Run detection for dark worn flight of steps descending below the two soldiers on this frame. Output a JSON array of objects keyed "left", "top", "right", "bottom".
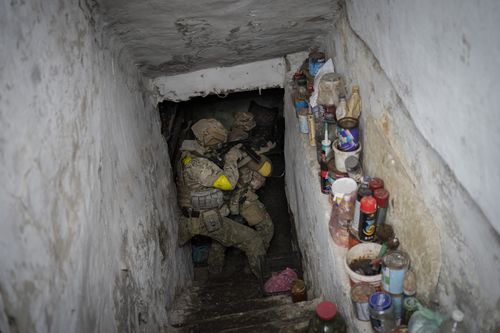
[{"left": 169, "top": 273, "right": 319, "bottom": 333}]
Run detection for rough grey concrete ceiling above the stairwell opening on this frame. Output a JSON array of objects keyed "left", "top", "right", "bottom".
[{"left": 98, "top": 0, "right": 339, "bottom": 77}]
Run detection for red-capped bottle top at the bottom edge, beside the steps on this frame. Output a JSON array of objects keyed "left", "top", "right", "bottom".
[{"left": 307, "top": 301, "right": 347, "bottom": 333}]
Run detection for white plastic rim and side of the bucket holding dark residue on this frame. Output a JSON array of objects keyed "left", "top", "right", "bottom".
[{"left": 344, "top": 243, "right": 382, "bottom": 288}]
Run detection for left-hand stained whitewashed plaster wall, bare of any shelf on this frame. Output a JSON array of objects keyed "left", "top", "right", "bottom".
[{"left": 0, "top": 0, "right": 191, "bottom": 333}]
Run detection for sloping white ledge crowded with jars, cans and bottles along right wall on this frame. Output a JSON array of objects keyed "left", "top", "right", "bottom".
[{"left": 285, "top": 53, "right": 459, "bottom": 332}]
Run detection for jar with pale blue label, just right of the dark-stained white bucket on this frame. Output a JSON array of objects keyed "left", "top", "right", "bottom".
[{"left": 382, "top": 250, "right": 410, "bottom": 295}]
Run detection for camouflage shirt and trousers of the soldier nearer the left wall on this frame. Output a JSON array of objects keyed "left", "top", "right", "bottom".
[{"left": 178, "top": 118, "right": 265, "bottom": 276}]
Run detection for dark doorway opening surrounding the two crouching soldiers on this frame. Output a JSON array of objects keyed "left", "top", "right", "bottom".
[{"left": 159, "top": 89, "right": 301, "bottom": 279}]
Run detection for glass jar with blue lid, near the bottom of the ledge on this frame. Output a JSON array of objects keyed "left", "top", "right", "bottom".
[{"left": 369, "top": 292, "right": 396, "bottom": 333}]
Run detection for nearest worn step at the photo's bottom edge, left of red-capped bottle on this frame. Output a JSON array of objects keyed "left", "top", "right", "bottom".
[{"left": 175, "top": 299, "right": 320, "bottom": 333}]
